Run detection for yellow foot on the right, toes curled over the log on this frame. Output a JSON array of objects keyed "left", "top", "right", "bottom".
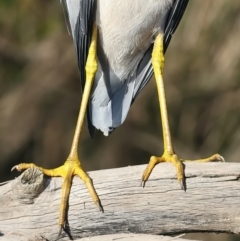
[{"left": 141, "top": 152, "right": 224, "bottom": 190}]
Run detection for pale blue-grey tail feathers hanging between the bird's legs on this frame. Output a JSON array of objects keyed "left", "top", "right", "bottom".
[{"left": 88, "top": 46, "right": 153, "bottom": 136}]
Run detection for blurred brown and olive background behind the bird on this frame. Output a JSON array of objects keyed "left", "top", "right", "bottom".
[{"left": 0, "top": 0, "right": 240, "bottom": 241}]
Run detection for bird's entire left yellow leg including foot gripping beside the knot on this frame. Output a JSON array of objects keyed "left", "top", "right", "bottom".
[{"left": 12, "top": 24, "right": 103, "bottom": 235}]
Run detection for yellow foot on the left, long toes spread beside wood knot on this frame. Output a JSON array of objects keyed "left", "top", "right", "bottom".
[{"left": 11, "top": 158, "right": 103, "bottom": 234}]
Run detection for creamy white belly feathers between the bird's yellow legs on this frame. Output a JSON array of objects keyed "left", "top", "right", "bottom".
[{"left": 96, "top": 0, "right": 173, "bottom": 80}]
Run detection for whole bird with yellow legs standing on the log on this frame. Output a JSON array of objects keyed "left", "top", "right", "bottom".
[{"left": 12, "top": 0, "right": 223, "bottom": 232}]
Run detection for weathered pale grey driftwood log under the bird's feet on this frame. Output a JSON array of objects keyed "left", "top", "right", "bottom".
[{"left": 0, "top": 163, "right": 240, "bottom": 241}]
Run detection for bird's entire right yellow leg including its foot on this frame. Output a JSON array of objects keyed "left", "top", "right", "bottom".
[{"left": 141, "top": 34, "right": 224, "bottom": 190}]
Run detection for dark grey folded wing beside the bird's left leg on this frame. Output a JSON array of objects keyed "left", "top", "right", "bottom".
[{"left": 60, "top": 0, "right": 95, "bottom": 136}]
